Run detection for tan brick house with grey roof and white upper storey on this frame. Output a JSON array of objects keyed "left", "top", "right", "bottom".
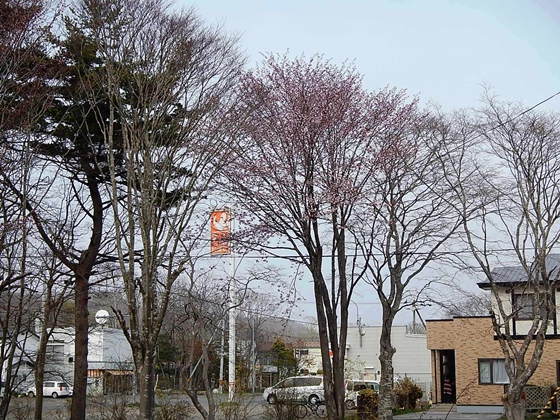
[{"left": 426, "top": 254, "right": 560, "bottom": 414}]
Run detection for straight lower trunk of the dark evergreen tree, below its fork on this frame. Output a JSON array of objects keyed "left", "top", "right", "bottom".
[{"left": 70, "top": 275, "right": 89, "bottom": 420}]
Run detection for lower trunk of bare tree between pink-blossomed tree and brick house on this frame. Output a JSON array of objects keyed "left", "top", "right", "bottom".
[{"left": 378, "top": 320, "right": 395, "bottom": 420}]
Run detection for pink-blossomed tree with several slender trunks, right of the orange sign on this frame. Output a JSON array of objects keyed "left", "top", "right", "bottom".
[{"left": 225, "top": 55, "right": 414, "bottom": 419}]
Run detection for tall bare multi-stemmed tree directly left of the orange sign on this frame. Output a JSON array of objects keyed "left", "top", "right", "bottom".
[{"left": 80, "top": 0, "right": 243, "bottom": 419}]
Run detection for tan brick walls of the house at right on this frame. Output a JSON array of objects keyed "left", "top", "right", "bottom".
[{"left": 427, "top": 317, "right": 560, "bottom": 405}]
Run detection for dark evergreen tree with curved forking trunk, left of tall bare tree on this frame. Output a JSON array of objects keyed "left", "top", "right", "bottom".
[{"left": 0, "top": 1, "right": 122, "bottom": 419}]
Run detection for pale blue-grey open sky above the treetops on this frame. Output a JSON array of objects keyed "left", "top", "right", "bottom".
[{"left": 177, "top": 0, "right": 560, "bottom": 325}]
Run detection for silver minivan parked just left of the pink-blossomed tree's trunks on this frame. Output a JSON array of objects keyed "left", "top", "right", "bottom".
[{"left": 263, "top": 376, "right": 324, "bottom": 404}]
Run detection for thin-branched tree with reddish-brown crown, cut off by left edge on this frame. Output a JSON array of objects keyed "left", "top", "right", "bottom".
[{"left": 0, "top": 0, "right": 67, "bottom": 418}]
